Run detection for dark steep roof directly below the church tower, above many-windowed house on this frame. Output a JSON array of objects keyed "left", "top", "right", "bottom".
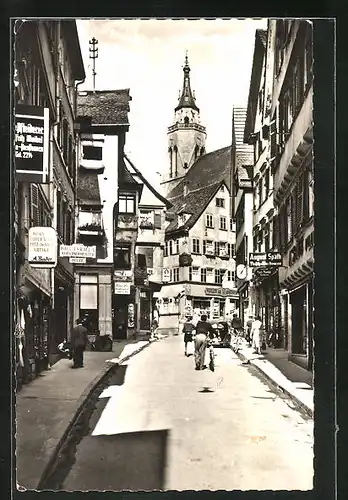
[{"left": 166, "top": 146, "right": 231, "bottom": 232}]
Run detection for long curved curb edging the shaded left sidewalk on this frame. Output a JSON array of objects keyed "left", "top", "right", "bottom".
[{"left": 37, "top": 341, "right": 152, "bottom": 491}]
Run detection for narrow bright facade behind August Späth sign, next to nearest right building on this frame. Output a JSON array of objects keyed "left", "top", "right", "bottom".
[{"left": 244, "top": 26, "right": 287, "bottom": 340}]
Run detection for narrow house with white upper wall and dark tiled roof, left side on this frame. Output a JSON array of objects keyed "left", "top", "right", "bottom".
[{"left": 74, "top": 89, "right": 131, "bottom": 337}]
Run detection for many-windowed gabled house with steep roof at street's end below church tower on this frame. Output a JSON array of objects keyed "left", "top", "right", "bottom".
[{"left": 159, "top": 147, "right": 238, "bottom": 333}]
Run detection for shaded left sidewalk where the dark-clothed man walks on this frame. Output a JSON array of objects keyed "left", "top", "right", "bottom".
[{"left": 16, "top": 340, "right": 149, "bottom": 490}]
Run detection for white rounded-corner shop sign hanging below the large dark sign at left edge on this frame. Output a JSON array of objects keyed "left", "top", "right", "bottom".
[{"left": 28, "top": 227, "right": 57, "bottom": 268}]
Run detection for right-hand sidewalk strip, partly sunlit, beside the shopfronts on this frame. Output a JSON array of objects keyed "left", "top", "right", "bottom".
[{"left": 234, "top": 343, "right": 314, "bottom": 417}]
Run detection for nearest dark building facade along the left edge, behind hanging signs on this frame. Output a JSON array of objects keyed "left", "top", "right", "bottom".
[{"left": 13, "top": 20, "right": 85, "bottom": 386}]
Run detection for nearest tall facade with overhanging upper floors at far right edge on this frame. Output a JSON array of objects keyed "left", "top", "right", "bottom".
[{"left": 268, "top": 20, "right": 314, "bottom": 369}]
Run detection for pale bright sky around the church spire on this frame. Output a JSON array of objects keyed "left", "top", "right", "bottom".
[{"left": 77, "top": 19, "right": 267, "bottom": 188}]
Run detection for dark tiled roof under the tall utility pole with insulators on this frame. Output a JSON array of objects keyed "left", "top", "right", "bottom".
[{"left": 77, "top": 89, "right": 132, "bottom": 125}]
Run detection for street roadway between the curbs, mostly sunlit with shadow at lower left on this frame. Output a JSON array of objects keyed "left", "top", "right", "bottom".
[{"left": 62, "top": 336, "right": 313, "bottom": 491}]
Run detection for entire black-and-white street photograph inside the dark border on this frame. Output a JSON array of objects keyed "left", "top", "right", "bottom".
[{"left": 12, "top": 18, "right": 315, "bottom": 492}]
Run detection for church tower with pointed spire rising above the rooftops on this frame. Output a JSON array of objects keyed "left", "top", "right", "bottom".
[{"left": 161, "top": 52, "right": 207, "bottom": 195}]
